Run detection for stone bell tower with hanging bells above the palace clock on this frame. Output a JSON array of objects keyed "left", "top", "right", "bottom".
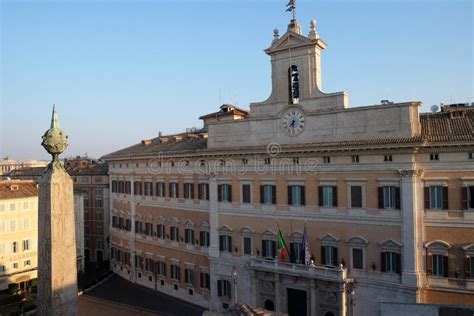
[{"left": 251, "top": 17, "right": 348, "bottom": 116}]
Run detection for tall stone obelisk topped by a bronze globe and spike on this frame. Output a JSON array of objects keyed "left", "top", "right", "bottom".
[{"left": 37, "top": 106, "right": 78, "bottom": 316}]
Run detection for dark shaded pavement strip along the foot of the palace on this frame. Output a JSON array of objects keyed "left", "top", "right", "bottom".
[{"left": 83, "top": 275, "right": 206, "bottom": 316}]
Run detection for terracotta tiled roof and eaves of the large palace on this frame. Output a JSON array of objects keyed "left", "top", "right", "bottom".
[{"left": 102, "top": 108, "right": 474, "bottom": 159}]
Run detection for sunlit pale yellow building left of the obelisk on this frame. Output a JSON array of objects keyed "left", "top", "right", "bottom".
[{"left": 0, "top": 181, "right": 38, "bottom": 290}]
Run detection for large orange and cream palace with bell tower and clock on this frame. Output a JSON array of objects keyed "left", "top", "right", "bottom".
[{"left": 103, "top": 15, "right": 474, "bottom": 316}]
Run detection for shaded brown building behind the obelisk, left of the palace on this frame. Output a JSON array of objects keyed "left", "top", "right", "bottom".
[{"left": 8, "top": 156, "right": 110, "bottom": 262}]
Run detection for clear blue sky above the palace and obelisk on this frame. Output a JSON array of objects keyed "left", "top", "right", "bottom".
[{"left": 0, "top": 0, "right": 474, "bottom": 159}]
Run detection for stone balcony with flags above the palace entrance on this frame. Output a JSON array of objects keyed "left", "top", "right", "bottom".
[{"left": 250, "top": 259, "right": 347, "bottom": 282}]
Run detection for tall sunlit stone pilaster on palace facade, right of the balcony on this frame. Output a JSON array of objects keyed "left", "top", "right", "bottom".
[{"left": 400, "top": 170, "right": 423, "bottom": 289}]
